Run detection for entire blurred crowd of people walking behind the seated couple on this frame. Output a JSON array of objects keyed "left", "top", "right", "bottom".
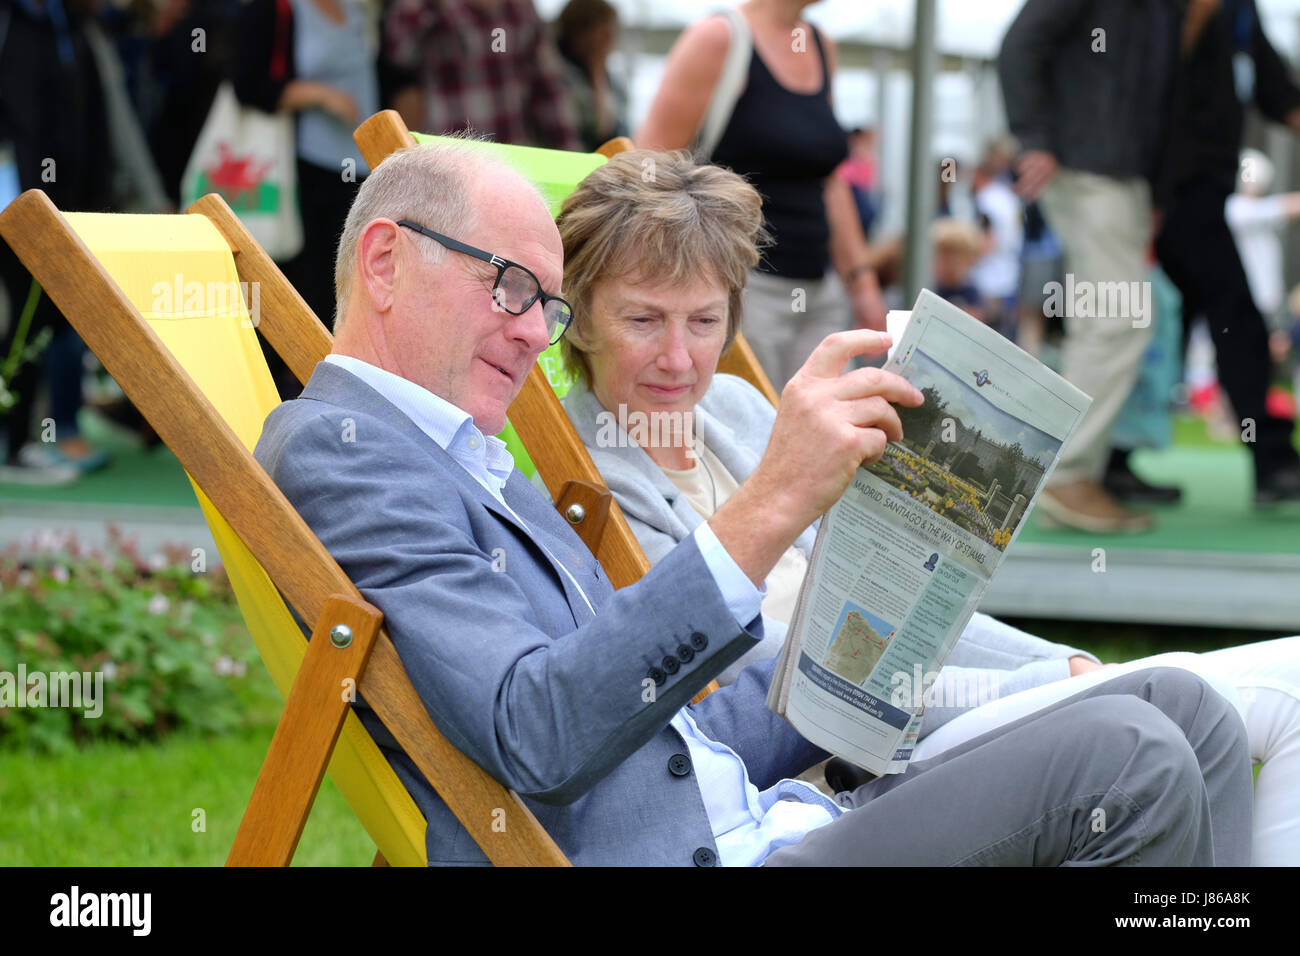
[{"left": 0, "top": 0, "right": 1300, "bottom": 531}]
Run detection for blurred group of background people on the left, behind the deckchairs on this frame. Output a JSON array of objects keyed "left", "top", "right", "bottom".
[{"left": 0, "top": 0, "right": 628, "bottom": 485}]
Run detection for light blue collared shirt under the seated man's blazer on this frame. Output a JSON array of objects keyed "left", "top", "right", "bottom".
[{"left": 325, "top": 355, "right": 844, "bottom": 866}]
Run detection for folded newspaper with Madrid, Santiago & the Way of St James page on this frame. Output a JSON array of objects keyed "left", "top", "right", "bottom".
[{"left": 767, "top": 290, "right": 1092, "bottom": 774}]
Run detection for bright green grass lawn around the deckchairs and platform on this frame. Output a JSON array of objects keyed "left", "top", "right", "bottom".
[{"left": 0, "top": 408, "right": 1283, "bottom": 866}]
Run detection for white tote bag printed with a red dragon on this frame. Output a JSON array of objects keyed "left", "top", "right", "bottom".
[{"left": 181, "top": 81, "right": 303, "bottom": 261}]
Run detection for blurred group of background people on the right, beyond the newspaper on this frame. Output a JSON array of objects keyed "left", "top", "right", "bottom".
[{"left": 840, "top": 0, "right": 1300, "bottom": 532}]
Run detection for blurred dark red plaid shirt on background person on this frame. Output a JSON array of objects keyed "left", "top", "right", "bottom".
[{"left": 384, "top": 0, "right": 582, "bottom": 150}]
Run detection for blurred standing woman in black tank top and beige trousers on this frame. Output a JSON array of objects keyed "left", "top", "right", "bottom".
[{"left": 636, "top": 0, "right": 884, "bottom": 388}]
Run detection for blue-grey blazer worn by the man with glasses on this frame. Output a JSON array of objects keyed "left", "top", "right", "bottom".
[{"left": 255, "top": 363, "right": 827, "bottom": 866}]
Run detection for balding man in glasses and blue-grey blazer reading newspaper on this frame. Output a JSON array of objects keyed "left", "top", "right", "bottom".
[{"left": 256, "top": 141, "right": 1251, "bottom": 866}]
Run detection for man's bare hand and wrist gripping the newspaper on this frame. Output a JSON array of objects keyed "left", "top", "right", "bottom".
[{"left": 709, "top": 329, "right": 924, "bottom": 587}]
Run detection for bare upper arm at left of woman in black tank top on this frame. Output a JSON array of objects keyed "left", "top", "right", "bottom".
[{"left": 633, "top": 17, "right": 731, "bottom": 150}]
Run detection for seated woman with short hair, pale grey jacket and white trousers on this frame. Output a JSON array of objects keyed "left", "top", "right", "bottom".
[{"left": 558, "top": 151, "right": 1300, "bottom": 865}]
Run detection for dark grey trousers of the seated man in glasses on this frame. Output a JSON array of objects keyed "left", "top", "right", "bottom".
[{"left": 767, "top": 667, "right": 1252, "bottom": 866}]
